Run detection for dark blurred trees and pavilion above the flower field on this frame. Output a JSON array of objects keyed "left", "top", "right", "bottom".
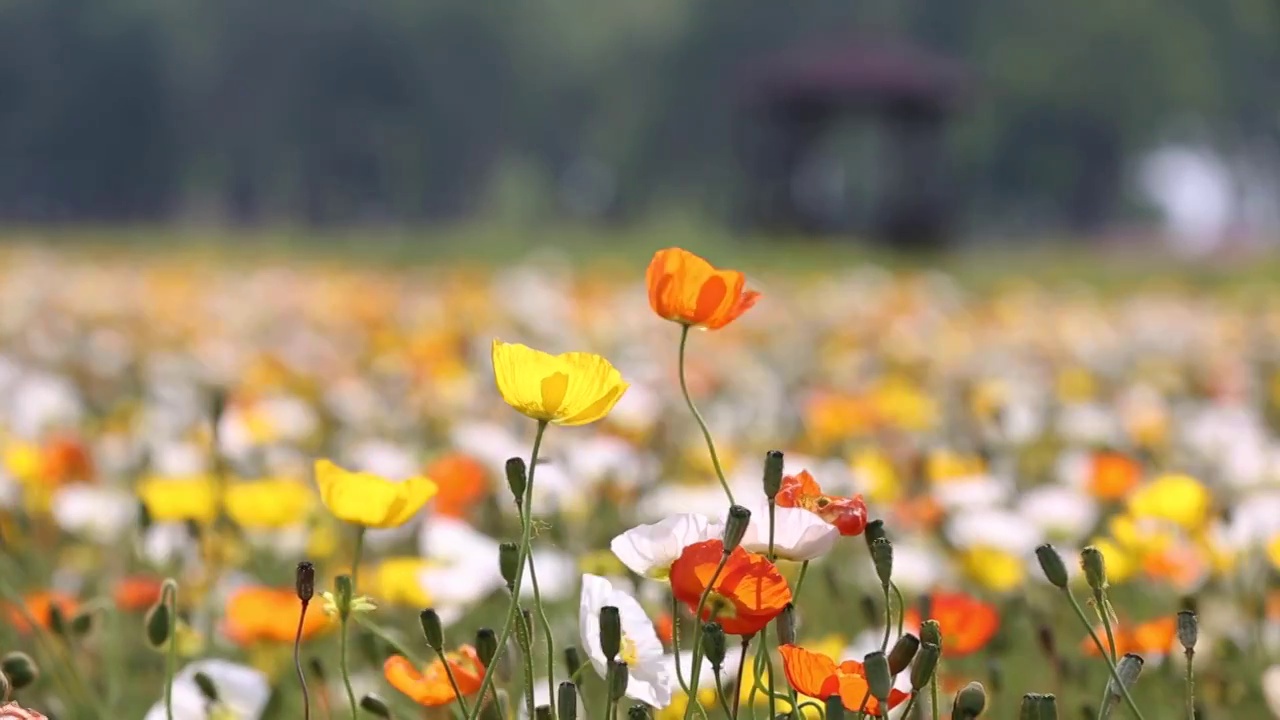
[{"left": 0, "top": 0, "right": 1280, "bottom": 254}]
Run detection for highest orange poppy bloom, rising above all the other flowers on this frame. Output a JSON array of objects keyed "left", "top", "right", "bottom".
[{"left": 645, "top": 247, "right": 760, "bottom": 331}]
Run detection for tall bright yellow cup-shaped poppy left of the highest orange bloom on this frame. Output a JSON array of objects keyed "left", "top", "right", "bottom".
[{"left": 493, "top": 340, "right": 630, "bottom": 425}]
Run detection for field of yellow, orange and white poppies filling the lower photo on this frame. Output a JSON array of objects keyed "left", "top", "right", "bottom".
[{"left": 0, "top": 242, "right": 1280, "bottom": 720}]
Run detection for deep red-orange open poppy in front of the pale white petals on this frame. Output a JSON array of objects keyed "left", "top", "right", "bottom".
[{"left": 671, "top": 539, "right": 791, "bottom": 635}]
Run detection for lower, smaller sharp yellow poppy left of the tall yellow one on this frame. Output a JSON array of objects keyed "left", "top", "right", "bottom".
[{"left": 316, "top": 460, "right": 438, "bottom": 528}]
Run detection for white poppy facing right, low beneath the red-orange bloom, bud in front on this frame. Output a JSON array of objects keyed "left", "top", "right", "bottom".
[{"left": 579, "top": 575, "right": 675, "bottom": 707}]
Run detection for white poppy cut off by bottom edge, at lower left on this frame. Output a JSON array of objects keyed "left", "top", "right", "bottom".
[{"left": 143, "top": 660, "right": 271, "bottom": 720}]
